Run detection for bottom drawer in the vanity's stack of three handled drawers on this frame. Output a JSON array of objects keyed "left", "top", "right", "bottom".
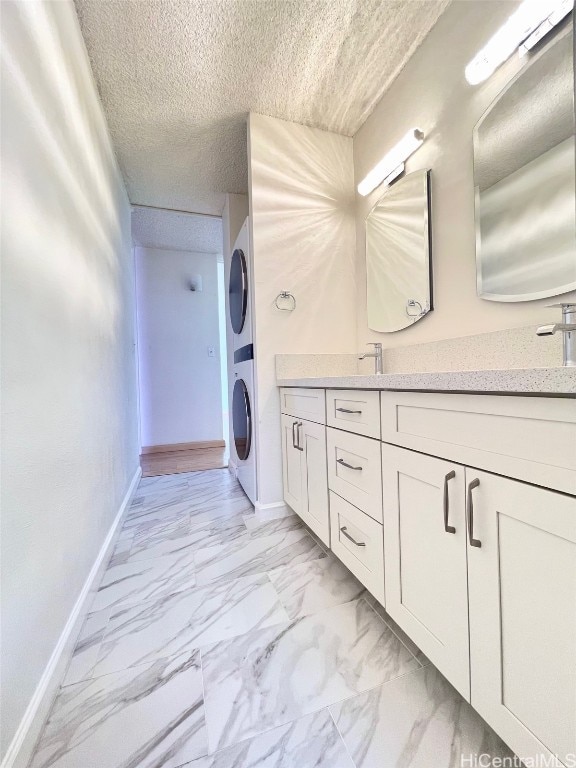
[{"left": 330, "top": 491, "right": 384, "bottom": 605}]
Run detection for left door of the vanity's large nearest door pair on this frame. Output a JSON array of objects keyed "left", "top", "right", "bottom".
[{"left": 382, "top": 444, "right": 470, "bottom": 700}]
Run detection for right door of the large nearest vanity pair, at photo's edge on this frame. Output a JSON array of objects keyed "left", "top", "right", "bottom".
[{"left": 466, "top": 468, "right": 576, "bottom": 765}]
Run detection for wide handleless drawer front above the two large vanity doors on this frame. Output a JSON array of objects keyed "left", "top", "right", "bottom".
[{"left": 381, "top": 392, "right": 576, "bottom": 495}]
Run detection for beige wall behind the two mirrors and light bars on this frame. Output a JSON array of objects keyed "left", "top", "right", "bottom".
[{"left": 354, "top": 0, "right": 576, "bottom": 347}]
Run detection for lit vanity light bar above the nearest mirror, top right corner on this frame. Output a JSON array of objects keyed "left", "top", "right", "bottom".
[{"left": 465, "top": 0, "right": 574, "bottom": 85}]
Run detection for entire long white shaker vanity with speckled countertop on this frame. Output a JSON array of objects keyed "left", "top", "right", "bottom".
[{"left": 278, "top": 378, "right": 576, "bottom": 765}]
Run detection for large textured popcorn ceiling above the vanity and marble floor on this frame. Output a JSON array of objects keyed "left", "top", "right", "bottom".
[{"left": 76, "top": 0, "right": 448, "bottom": 214}]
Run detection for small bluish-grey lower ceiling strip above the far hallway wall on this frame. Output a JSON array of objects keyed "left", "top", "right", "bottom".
[{"left": 132, "top": 208, "right": 222, "bottom": 254}]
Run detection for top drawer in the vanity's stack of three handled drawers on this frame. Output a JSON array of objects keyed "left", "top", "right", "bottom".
[{"left": 326, "top": 389, "right": 380, "bottom": 439}]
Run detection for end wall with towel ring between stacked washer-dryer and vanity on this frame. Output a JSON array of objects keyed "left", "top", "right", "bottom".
[{"left": 248, "top": 114, "right": 356, "bottom": 505}]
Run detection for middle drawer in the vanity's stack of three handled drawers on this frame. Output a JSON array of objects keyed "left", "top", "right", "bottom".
[{"left": 327, "top": 427, "right": 382, "bottom": 522}]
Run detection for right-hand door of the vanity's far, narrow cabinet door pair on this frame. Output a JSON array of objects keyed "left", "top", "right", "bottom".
[{"left": 297, "top": 421, "right": 330, "bottom": 547}]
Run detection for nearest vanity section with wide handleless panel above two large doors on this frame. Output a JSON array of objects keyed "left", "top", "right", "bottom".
[{"left": 382, "top": 392, "right": 576, "bottom": 765}]
